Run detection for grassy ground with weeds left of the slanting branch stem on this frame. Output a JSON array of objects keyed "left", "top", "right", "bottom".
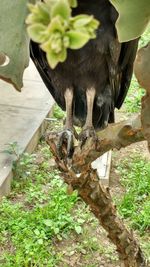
[{"left": 0, "top": 144, "right": 117, "bottom": 267}]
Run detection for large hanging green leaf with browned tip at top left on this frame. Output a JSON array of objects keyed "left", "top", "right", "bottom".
[{"left": 0, "top": 0, "right": 33, "bottom": 91}]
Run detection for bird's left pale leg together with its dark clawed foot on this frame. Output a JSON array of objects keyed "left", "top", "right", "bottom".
[{"left": 57, "top": 88, "right": 74, "bottom": 158}]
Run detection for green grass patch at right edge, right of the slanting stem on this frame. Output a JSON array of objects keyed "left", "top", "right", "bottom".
[{"left": 118, "top": 155, "right": 150, "bottom": 233}]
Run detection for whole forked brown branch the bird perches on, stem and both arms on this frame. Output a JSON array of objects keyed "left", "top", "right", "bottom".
[{"left": 46, "top": 116, "right": 147, "bottom": 267}]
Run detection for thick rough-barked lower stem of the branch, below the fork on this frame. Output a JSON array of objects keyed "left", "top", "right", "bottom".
[{"left": 64, "top": 169, "right": 146, "bottom": 267}]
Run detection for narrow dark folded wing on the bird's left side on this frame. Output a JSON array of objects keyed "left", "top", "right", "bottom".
[{"left": 30, "top": 41, "right": 65, "bottom": 110}]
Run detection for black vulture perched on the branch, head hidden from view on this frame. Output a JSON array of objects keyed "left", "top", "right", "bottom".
[{"left": 30, "top": 0, "right": 138, "bottom": 157}]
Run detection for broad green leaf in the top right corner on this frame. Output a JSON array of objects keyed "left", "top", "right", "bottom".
[{"left": 109, "top": 0, "right": 150, "bottom": 42}]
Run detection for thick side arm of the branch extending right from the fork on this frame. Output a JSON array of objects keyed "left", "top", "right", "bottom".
[{"left": 73, "top": 116, "right": 145, "bottom": 169}]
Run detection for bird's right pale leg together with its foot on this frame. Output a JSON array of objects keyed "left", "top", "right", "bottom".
[{"left": 79, "top": 87, "right": 96, "bottom": 144}]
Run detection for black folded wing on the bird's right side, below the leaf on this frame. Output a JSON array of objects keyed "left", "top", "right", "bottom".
[{"left": 108, "top": 39, "right": 139, "bottom": 109}]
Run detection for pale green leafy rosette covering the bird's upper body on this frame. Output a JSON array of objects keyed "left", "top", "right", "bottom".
[{"left": 26, "top": 0, "right": 99, "bottom": 69}]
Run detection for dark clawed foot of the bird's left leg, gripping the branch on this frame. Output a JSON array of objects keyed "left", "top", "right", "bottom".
[{"left": 57, "top": 129, "right": 74, "bottom": 159}]
